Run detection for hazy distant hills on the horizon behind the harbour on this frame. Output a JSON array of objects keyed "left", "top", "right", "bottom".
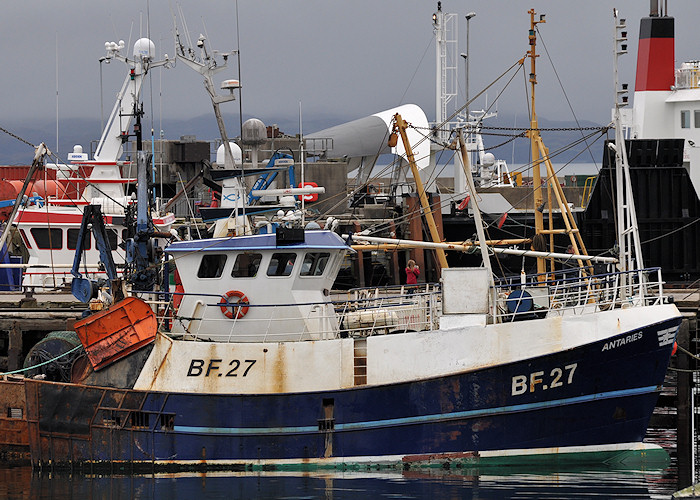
[{"left": 0, "top": 113, "right": 602, "bottom": 169}]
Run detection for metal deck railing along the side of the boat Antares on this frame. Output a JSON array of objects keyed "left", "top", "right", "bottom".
[{"left": 152, "top": 268, "right": 665, "bottom": 342}]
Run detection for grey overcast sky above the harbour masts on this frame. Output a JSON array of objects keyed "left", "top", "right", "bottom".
[{"left": 0, "top": 0, "right": 700, "bottom": 145}]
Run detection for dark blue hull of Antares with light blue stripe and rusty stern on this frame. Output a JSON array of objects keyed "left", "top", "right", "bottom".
[{"left": 26, "top": 318, "right": 680, "bottom": 468}]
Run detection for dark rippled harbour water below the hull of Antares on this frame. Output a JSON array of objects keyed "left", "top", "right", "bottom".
[{"left": 0, "top": 429, "right": 679, "bottom": 500}]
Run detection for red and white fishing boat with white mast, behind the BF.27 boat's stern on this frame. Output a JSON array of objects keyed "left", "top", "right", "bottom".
[{"left": 12, "top": 38, "right": 175, "bottom": 289}]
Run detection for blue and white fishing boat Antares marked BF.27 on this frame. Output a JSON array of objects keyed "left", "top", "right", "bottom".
[{"left": 20, "top": 6, "right": 681, "bottom": 472}]
